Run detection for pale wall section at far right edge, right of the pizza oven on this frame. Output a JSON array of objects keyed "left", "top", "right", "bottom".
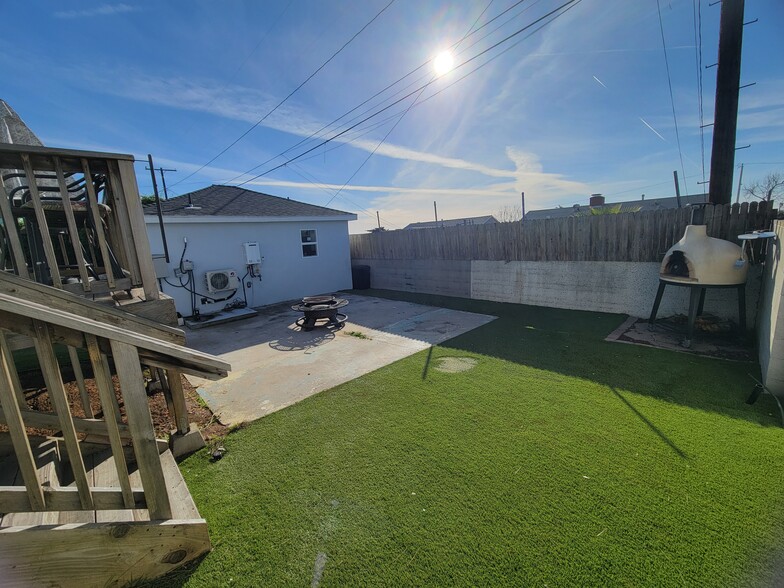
[{"left": 758, "top": 221, "right": 784, "bottom": 396}]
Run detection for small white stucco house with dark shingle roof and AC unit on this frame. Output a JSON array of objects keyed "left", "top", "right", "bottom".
[{"left": 144, "top": 185, "right": 357, "bottom": 317}]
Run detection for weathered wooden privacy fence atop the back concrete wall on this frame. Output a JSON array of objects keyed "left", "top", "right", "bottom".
[{"left": 350, "top": 202, "right": 775, "bottom": 261}]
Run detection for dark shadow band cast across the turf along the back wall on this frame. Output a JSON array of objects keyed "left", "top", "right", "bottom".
[{"left": 356, "top": 290, "right": 781, "bottom": 428}]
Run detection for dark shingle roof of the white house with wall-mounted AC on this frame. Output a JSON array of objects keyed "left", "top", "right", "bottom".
[{"left": 144, "top": 185, "right": 354, "bottom": 217}]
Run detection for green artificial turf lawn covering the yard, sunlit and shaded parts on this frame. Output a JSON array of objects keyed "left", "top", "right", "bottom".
[{"left": 153, "top": 292, "right": 784, "bottom": 587}]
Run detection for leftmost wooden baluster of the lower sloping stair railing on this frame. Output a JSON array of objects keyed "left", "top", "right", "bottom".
[{"left": 0, "top": 335, "right": 46, "bottom": 511}]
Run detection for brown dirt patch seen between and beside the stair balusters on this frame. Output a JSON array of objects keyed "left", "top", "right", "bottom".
[{"left": 0, "top": 376, "right": 228, "bottom": 440}]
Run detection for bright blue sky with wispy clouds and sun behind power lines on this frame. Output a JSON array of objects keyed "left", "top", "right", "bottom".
[{"left": 0, "top": 0, "right": 784, "bottom": 232}]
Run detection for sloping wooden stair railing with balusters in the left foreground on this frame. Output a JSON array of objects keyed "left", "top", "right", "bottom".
[{"left": 0, "top": 290, "right": 230, "bottom": 520}]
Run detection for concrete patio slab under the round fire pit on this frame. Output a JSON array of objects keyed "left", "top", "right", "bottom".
[{"left": 186, "top": 295, "right": 496, "bottom": 425}]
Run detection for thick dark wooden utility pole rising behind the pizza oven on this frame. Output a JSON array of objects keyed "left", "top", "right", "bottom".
[{"left": 709, "top": 0, "right": 744, "bottom": 204}]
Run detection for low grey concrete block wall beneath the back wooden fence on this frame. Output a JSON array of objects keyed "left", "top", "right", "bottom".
[{"left": 352, "top": 259, "right": 760, "bottom": 327}]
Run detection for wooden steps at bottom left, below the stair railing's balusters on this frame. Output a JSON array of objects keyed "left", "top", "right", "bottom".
[{"left": 0, "top": 434, "right": 211, "bottom": 588}]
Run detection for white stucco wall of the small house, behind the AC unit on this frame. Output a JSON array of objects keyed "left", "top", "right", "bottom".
[{"left": 145, "top": 218, "right": 351, "bottom": 316}]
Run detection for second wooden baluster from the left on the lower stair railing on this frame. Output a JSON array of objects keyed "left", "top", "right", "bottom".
[{"left": 33, "top": 320, "right": 94, "bottom": 510}]
